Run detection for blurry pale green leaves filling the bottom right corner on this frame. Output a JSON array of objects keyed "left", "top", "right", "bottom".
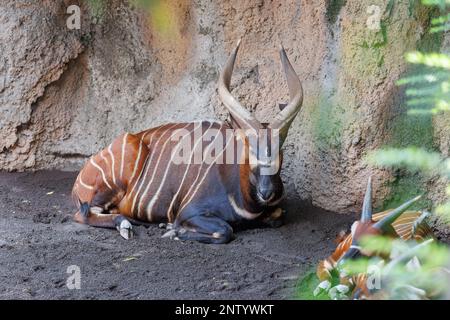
[{"left": 342, "top": 236, "right": 450, "bottom": 299}]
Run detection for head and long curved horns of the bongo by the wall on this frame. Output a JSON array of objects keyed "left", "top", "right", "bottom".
[{"left": 218, "top": 40, "right": 303, "bottom": 206}]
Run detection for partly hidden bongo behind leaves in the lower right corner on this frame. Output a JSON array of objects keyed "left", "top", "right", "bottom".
[{"left": 316, "top": 178, "right": 432, "bottom": 298}]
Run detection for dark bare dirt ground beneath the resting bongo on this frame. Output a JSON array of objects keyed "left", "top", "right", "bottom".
[{"left": 0, "top": 171, "right": 353, "bottom": 299}]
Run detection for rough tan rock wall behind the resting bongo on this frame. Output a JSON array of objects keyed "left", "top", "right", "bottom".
[{"left": 0, "top": 0, "right": 450, "bottom": 212}]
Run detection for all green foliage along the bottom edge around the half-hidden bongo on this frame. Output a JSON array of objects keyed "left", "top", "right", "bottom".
[{"left": 308, "top": 236, "right": 450, "bottom": 300}]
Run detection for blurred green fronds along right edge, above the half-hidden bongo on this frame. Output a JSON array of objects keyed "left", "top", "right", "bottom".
[{"left": 368, "top": 0, "right": 450, "bottom": 220}]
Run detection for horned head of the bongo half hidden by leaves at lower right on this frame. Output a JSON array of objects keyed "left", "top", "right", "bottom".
[{"left": 339, "top": 177, "right": 421, "bottom": 263}]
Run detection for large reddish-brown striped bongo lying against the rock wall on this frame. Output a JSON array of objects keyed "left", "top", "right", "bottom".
[{"left": 72, "top": 42, "right": 303, "bottom": 243}]
